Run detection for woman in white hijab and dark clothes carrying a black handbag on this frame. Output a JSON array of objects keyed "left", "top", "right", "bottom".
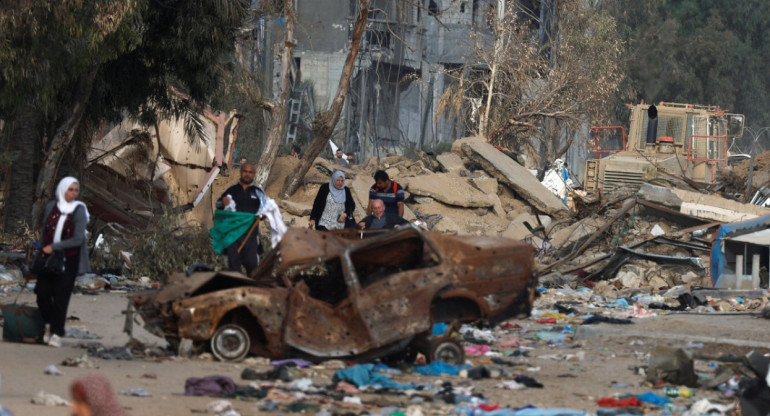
[{"left": 35, "top": 176, "right": 91, "bottom": 347}]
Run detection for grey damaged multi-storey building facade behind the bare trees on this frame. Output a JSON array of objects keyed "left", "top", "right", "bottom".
[{"left": 264, "top": 0, "right": 496, "bottom": 160}]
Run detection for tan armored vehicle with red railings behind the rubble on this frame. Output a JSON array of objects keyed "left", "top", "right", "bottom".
[{"left": 584, "top": 102, "right": 744, "bottom": 191}]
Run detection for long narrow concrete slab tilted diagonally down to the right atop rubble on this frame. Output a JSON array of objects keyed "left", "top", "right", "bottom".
[{"left": 462, "top": 142, "right": 567, "bottom": 215}]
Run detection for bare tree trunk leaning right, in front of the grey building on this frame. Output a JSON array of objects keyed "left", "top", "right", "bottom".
[{"left": 278, "top": 0, "right": 369, "bottom": 199}]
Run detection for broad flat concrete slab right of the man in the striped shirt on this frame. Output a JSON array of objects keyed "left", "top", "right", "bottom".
[{"left": 409, "top": 173, "right": 492, "bottom": 208}]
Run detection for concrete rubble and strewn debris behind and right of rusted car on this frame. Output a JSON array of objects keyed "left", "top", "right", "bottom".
[{"left": 0, "top": 138, "right": 770, "bottom": 415}]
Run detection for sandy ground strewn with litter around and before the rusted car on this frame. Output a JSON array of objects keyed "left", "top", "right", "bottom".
[{"left": 0, "top": 293, "right": 770, "bottom": 416}]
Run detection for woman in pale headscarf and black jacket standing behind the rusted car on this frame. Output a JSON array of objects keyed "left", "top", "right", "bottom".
[{"left": 308, "top": 170, "right": 356, "bottom": 230}]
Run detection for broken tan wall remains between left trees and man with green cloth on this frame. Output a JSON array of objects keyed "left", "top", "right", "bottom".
[{"left": 85, "top": 113, "right": 237, "bottom": 227}]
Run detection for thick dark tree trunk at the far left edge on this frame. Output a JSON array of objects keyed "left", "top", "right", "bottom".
[{"left": 5, "top": 106, "right": 42, "bottom": 234}]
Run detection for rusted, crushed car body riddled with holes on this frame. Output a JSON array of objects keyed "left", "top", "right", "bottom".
[{"left": 132, "top": 225, "right": 536, "bottom": 360}]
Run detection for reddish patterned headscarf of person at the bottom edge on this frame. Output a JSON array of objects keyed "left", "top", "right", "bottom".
[{"left": 70, "top": 374, "right": 126, "bottom": 416}]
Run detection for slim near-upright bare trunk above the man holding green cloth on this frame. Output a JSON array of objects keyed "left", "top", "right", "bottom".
[{"left": 254, "top": 0, "right": 294, "bottom": 188}]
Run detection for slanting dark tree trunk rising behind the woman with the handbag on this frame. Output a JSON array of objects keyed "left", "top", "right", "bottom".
[{"left": 32, "top": 69, "right": 96, "bottom": 230}]
